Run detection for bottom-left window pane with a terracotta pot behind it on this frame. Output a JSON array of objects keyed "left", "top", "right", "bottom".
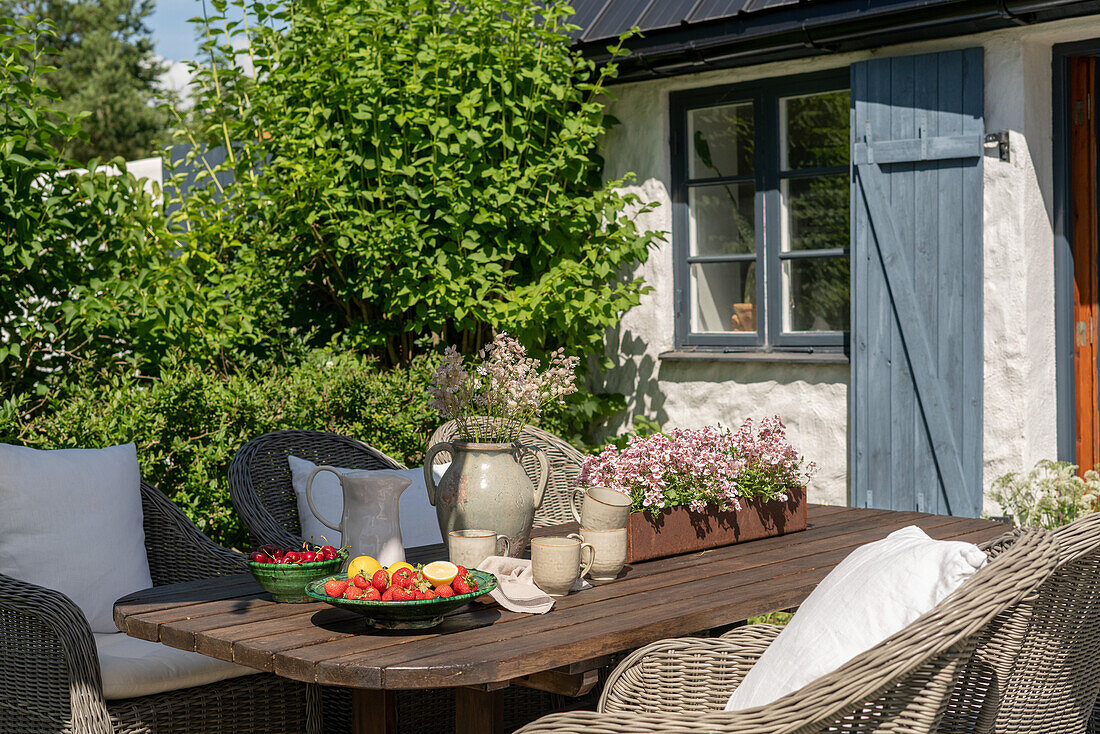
[{"left": 691, "top": 261, "right": 757, "bottom": 332}]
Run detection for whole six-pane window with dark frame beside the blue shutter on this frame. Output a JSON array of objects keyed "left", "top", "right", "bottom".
[{"left": 671, "top": 69, "right": 850, "bottom": 351}]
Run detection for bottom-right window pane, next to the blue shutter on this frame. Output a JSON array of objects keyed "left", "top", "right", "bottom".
[{"left": 783, "top": 258, "right": 849, "bottom": 331}]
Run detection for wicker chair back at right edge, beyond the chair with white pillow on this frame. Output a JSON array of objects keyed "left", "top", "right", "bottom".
[{"left": 942, "top": 514, "right": 1100, "bottom": 734}]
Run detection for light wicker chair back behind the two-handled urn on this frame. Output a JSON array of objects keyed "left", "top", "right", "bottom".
[{"left": 428, "top": 420, "right": 584, "bottom": 527}]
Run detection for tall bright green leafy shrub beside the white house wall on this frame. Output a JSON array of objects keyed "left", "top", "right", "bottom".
[{"left": 170, "top": 0, "right": 655, "bottom": 363}]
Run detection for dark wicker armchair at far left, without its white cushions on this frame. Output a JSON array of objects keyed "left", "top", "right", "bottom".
[{"left": 0, "top": 482, "right": 320, "bottom": 734}]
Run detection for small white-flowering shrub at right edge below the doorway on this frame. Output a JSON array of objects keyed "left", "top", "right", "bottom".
[{"left": 989, "top": 459, "right": 1100, "bottom": 529}]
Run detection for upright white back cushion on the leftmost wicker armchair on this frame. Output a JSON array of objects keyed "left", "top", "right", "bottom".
[{"left": 0, "top": 443, "right": 153, "bottom": 632}]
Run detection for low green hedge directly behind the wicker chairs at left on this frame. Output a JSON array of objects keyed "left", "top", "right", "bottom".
[{"left": 0, "top": 350, "right": 439, "bottom": 548}]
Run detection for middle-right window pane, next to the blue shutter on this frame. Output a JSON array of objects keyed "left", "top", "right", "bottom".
[{"left": 780, "top": 173, "right": 850, "bottom": 251}]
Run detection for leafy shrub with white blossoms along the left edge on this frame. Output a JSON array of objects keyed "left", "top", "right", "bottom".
[{"left": 0, "top": 18, "right": 249, "bottom": 415}]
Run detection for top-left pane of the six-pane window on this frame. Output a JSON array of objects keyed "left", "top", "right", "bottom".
[{"left": 688, "top": 102, "right": 752, "bottom": 178}]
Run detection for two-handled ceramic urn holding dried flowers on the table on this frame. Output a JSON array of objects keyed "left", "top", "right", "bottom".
[{"left": 424, "top": 441, "right": 550, "bottom": 558}]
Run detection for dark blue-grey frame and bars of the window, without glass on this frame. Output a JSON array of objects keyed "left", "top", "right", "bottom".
[{"left": 669, "top": 67, "right": 851, "bottom": 352}]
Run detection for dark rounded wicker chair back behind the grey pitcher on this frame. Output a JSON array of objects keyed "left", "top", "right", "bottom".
[{"left": 229, "top": 430, "right": 405, "bottom": 547}]
